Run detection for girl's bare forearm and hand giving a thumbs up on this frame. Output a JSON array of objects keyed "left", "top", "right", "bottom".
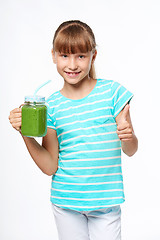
[{"left": 116, "top": 104, "right": 138, "bottom": 156}]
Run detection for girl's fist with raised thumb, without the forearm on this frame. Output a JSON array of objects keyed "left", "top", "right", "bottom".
[{"left": 116, "top": 104, "right": 133, "bottom": 142}]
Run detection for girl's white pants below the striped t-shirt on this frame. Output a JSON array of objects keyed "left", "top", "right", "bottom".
[{"left": 52, "top": 204, "right": 121, "bottom": 240}]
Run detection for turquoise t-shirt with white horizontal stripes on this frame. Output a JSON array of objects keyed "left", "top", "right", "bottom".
[{"left": 46, "top": 79, "right": 133, "bottom": 211}]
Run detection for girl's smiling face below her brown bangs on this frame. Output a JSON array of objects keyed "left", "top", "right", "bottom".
[{"left": 52, "top": 49, "right": 96, "bottom": 84}]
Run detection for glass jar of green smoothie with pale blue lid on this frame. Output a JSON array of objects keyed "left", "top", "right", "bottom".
[{"left": 21, "top": 96, "right": 47, "bottom": 137}]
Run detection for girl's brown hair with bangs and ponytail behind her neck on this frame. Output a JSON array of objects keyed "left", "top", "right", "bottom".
[{"left": 53, "top": 20, "right": 96, "bottom": 78}]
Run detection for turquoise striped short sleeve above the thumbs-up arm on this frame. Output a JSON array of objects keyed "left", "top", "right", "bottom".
[{"left": 111, "top": 81, "right": 133, "bottom": 117}]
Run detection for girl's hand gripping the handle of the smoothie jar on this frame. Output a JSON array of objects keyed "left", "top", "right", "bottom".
[{"left": 8, "top": 108, "right": 22, "bottom": 131}]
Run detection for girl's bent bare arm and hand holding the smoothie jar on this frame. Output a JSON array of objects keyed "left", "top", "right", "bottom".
[{"left": 9, "top": 108, "right": 59, "bottom": 175}]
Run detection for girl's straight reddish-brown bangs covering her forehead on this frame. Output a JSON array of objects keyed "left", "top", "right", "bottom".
[{"left": 53, "top": 25, "right": 95, "bottom": 54}]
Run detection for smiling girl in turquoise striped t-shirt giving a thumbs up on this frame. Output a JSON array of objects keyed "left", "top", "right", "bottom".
[{"left": 9, "top": 21, "right": 138, "bottom": 240}]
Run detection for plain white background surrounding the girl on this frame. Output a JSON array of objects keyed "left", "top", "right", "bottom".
[{"left": 0, "top": 0, "right": 160, "bottom": 240}]
